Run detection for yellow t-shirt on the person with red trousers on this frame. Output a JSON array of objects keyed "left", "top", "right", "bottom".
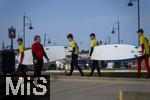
[{"left": 140, "top": 35, "right": 150, "bottom": 55}]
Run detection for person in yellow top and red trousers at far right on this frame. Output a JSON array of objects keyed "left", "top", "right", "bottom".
[{"left": 137, "top": 29, "right": 150, "bottom": 78}]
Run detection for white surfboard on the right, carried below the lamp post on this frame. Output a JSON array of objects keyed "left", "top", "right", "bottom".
[{"left": 91, "top": 44, "right": 141, "bottom": 60}]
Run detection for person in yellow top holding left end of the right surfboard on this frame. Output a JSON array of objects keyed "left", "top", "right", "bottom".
[{"left": 88, "top": 33, "right": 101, "bottom": 77}]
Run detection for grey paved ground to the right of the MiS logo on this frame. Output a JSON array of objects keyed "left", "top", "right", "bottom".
[{"left": 50, "top": 76, "right": 150, "bottom": 100}]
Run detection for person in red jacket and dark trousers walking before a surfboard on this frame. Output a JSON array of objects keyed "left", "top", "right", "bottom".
[{"left": 32, "top": 35, "right": 49, "bottom": 85}]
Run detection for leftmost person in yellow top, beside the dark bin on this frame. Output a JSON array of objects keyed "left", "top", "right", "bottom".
[{"left": 17, "top": 38, "right": 27, "bottom": 82}]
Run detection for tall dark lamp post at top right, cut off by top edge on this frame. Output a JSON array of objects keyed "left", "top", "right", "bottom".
[{"left": 128, "top": 0, "right": 140, "bottom": 45}]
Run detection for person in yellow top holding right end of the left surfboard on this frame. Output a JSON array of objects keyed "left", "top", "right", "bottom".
[{"left": 67, "top": 34, "right": 84, "bottom": 76}]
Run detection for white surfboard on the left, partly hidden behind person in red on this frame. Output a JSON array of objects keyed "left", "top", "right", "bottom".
[{"left": 18, "top": 46, "right": 71, "bottom": 65}]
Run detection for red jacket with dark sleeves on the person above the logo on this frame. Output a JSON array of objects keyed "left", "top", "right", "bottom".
[{"left": 32, "top": 43, "right": 48, "bottom": 59}]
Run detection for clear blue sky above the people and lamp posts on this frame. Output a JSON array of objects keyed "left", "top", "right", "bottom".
[{"left": 0, "top": 0, "right": 150, "bottom": 50}]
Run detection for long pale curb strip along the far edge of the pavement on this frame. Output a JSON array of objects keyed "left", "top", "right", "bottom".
[{"left": 50, "top": 75, "right": 150, "bottom": 85}]
